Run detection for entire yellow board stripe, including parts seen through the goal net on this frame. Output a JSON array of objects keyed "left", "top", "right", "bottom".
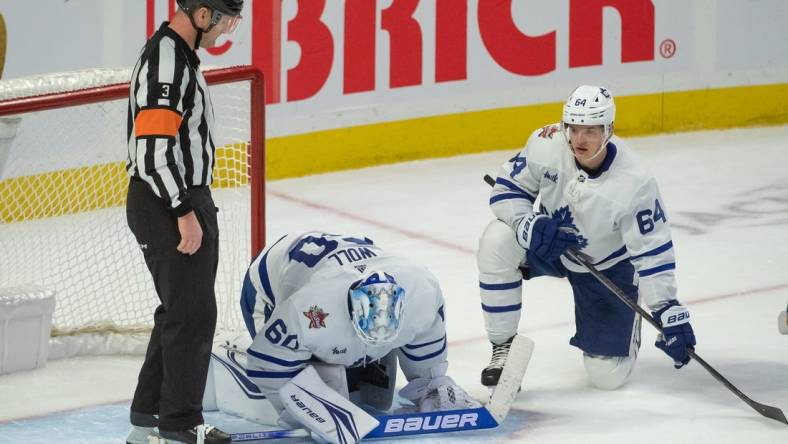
[{"left": 0, "top": 84, "right": 788, "bottom": 223}]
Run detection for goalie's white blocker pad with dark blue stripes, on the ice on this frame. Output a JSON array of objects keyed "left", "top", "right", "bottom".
[{"left": 279, "top": 365, "right": 378, "bottom": 444}]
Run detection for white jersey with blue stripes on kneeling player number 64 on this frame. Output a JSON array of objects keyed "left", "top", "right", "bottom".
[{"left": 490, "top": 124, "right": 676, "bottom": 310}]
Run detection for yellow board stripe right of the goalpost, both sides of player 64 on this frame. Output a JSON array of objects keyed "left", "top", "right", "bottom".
[{"left": 266, "top": 84, "right": 788, "bottom": 179}]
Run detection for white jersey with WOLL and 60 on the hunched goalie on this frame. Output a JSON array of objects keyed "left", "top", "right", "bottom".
[{"left": 241, "top": 232, "right": 446, "bottom": 404}]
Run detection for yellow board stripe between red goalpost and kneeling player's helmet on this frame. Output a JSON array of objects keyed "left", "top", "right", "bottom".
[{"left": 266, "top": 104, "right": 561, "bottom": 179}]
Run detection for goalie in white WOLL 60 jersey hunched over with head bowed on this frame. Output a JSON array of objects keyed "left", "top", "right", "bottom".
[{"left": 235, "top": 232, "right": 480, "bottom": 440}]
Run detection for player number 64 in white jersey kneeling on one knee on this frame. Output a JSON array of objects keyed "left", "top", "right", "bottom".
[{"left": 478, "top": 86, "right": 695, "bottom": 389}]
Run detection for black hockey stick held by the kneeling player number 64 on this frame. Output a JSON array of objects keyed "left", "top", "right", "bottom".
[{"left": 484, "top": 174, "right": 788, "bottom": 425}]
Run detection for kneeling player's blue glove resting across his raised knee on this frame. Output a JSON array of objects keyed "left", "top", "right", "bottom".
[{"left": 516, "top": 214, "right": 580, "bottom": 262}]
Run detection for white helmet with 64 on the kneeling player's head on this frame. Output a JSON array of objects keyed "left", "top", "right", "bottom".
[{"left": 561, "top": 85, "right": 616, "bottom": 142}]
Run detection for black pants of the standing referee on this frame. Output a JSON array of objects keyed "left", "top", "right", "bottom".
[{"left": 126, "top": 179, "right": 219, "bottom": 431}]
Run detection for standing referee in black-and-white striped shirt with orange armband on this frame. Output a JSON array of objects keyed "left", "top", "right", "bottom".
[{"left": 126, "top": 0, "right": 243, "bottom": 444}]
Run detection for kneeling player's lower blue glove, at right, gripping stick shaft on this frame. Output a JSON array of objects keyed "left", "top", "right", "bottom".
[{"left": 652, "top": 301, "right": 695, "bottom": 368}]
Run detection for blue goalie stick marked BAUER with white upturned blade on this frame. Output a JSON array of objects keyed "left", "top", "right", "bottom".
[{"left": 231, "top": 335, "right": 534, "bottom": 442}]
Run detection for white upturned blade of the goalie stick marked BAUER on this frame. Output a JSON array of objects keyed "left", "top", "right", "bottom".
[{"left": 487, "top": 335, "right": 534, "bottom": 424}]
